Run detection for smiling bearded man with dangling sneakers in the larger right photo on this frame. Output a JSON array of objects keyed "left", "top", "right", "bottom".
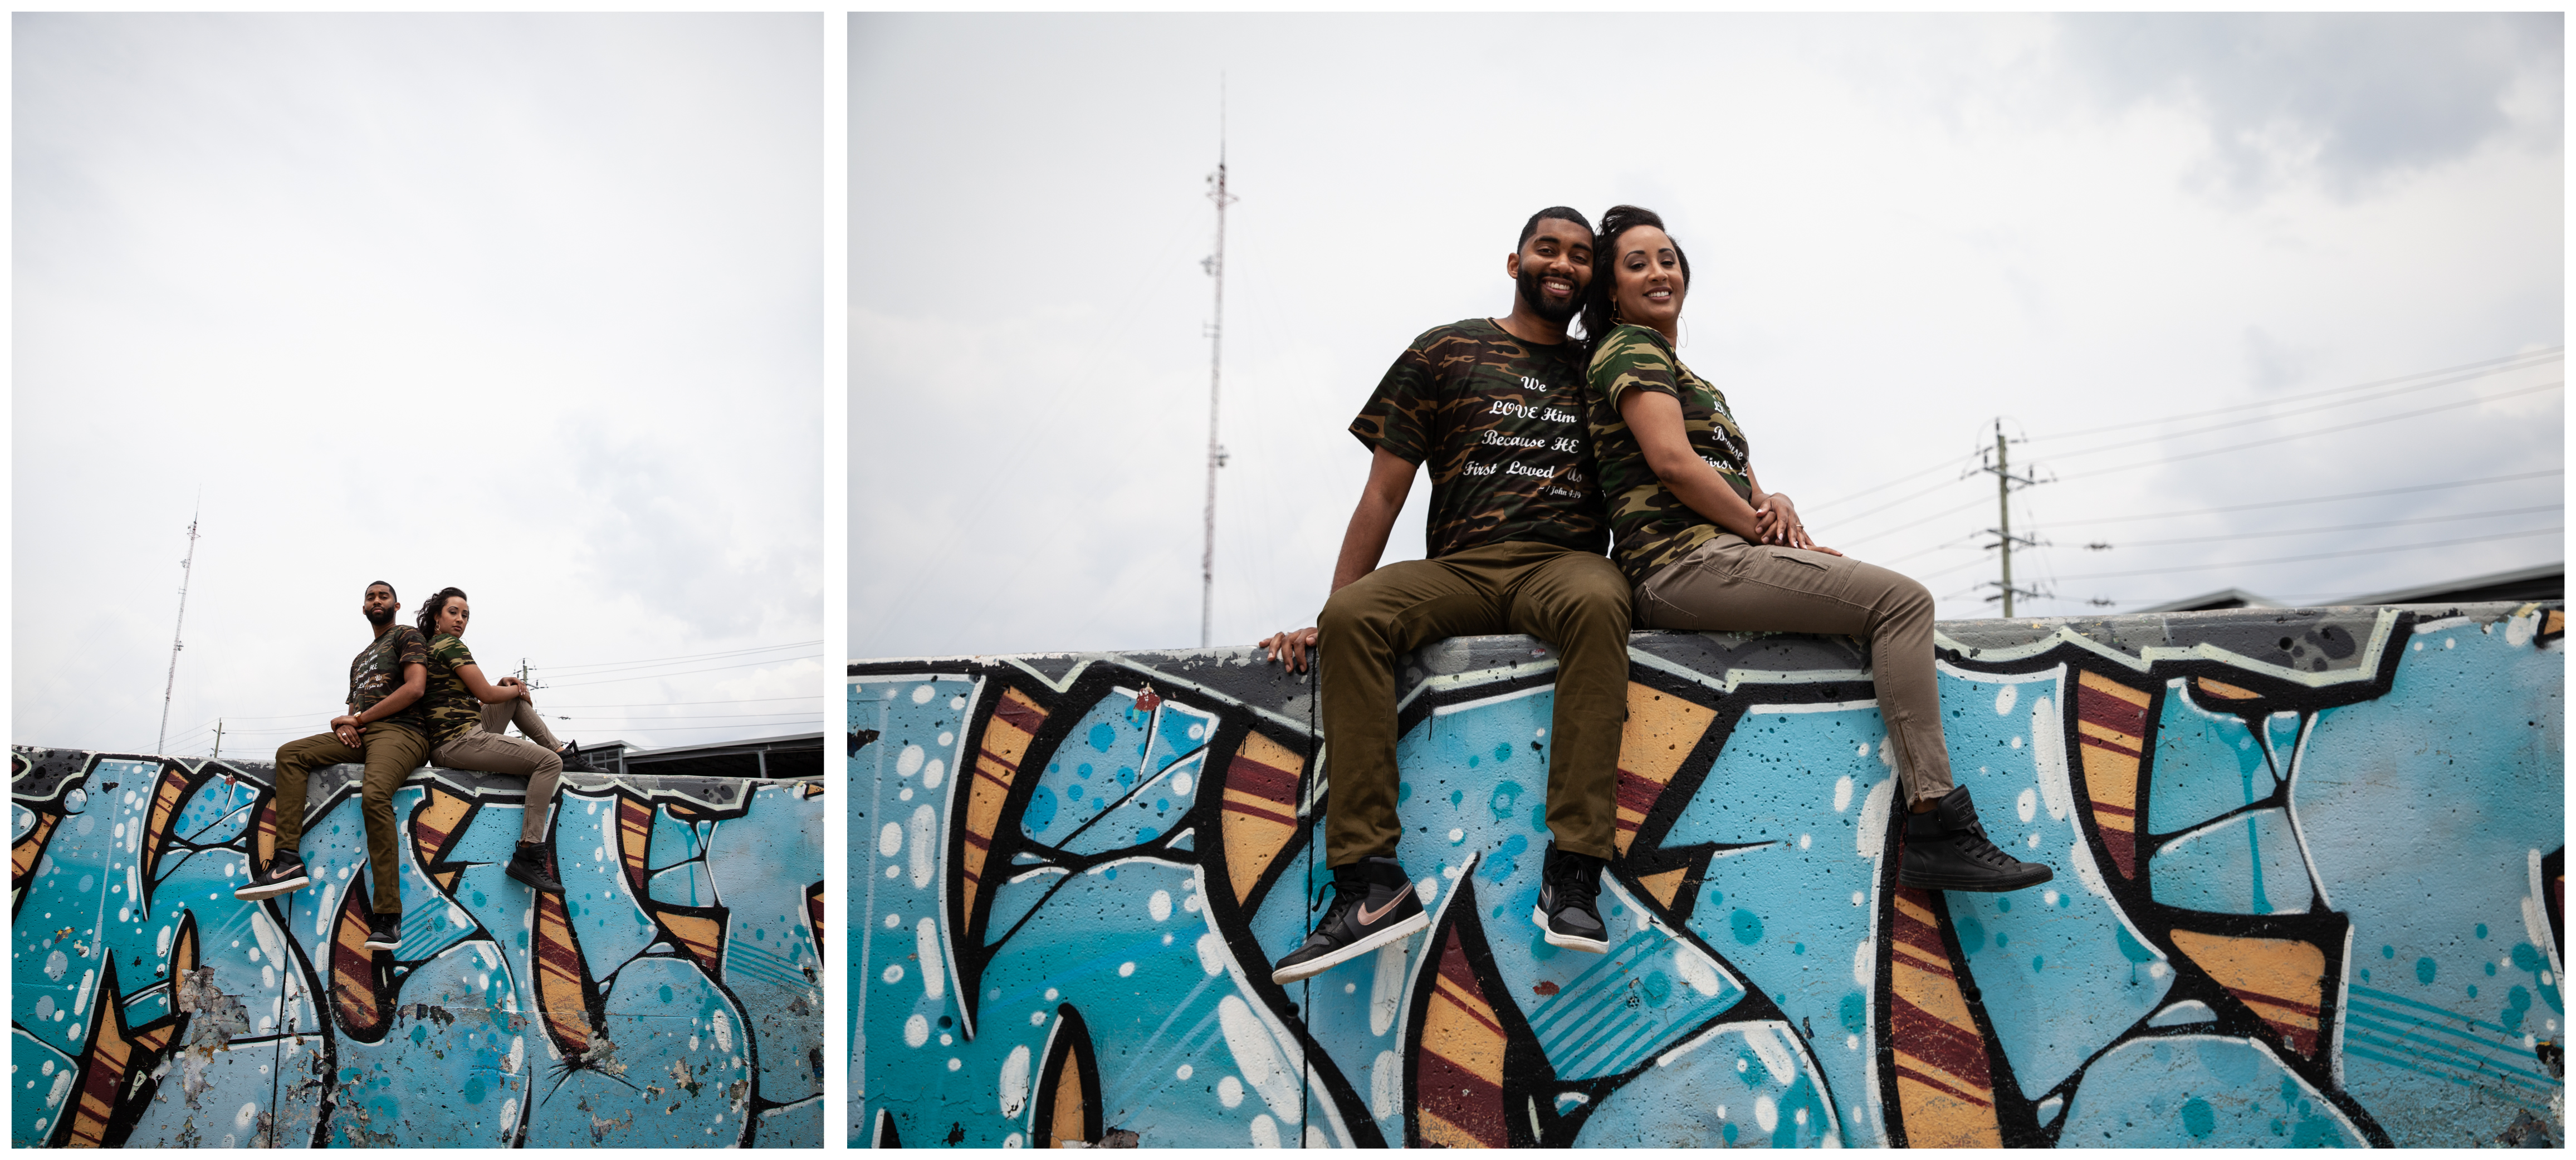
[{"left": 1262, "top": 206, "right": 1628, "bottom": 982}]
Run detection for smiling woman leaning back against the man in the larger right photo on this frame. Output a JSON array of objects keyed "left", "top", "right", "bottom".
[{"left": 1584, "top": 206, "right": 2051, "bottom": 892}]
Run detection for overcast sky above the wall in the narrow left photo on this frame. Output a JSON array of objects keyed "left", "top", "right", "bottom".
[{"left": 11, "top": 16, "right": 827, "bottom": 758}]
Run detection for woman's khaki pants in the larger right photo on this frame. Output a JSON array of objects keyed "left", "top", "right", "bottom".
[{"left": 1636, "top": 531, "right": 1950, "bottom": 804}]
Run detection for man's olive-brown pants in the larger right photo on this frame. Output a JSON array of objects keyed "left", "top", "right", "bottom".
[{"left": 1316, "top": 541, "right": 1628, "bottom": 866}]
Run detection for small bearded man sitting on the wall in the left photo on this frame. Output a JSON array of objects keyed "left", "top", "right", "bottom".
[{"left": 232, "top": 580, "right": 430, "bottom": 951}]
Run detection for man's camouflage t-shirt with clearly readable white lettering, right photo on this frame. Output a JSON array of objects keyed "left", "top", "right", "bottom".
[{"left": 1350, "top": 317, "right": 1610, "bottom": 559}]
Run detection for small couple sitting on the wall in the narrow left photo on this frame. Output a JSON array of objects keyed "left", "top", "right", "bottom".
[{"left": 232, "top": 580, "right": 595, "bottom": 951}]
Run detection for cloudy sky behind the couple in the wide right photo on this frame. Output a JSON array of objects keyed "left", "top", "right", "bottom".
[{"left": 850, "top": 16, "right": 2566, "bottom": 657}]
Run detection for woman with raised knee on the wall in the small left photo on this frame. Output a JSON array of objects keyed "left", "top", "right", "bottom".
[{"left": 420, "top": 588, "right": 580, "bottom": 894}]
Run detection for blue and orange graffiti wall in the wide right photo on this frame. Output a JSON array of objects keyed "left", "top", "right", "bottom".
[{"left": 848, "top": 606, "right": 2566, "bottom": 1147}]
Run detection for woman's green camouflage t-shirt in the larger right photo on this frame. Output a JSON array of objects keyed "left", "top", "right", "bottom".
[{"left": 1584, "top": 325, "right": 1754, "bottom": 583}]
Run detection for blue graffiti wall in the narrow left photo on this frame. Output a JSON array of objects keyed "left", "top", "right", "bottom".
[{"left": 11, "top": 747, "right": 824, "bottom": 1147}]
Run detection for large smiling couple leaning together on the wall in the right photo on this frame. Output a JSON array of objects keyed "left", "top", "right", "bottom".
[{"left": 1260, "top": 206, "right": 2051, "bottom": 982}]
